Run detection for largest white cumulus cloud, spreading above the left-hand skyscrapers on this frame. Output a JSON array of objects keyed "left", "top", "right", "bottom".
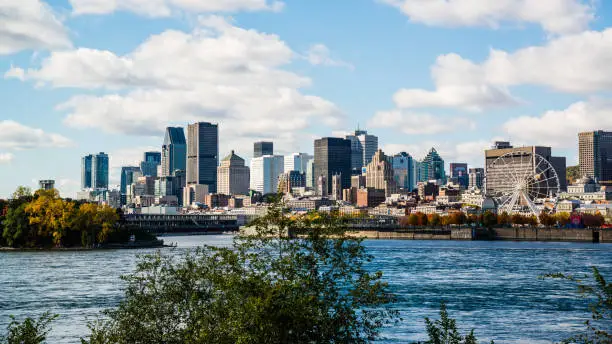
[{"left": 10, "top": 16, "right": 344, "bottom": 153}]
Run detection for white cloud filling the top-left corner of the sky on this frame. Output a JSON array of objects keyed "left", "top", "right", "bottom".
[{"left": 0, "top": 0, "right": 71, "bottom": 55}]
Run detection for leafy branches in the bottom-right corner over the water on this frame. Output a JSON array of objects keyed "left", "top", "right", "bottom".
[{"left": 544, "top": 266, "right": 612, "bottom": 344}]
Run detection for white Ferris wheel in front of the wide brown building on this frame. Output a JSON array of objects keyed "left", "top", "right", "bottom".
[{"left": 486, "top": 152, "right": 561, "bottom": 216}]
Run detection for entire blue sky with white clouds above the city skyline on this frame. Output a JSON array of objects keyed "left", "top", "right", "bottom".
[{"left": 0, "top": 0, "right": 612, "bottom": 197}]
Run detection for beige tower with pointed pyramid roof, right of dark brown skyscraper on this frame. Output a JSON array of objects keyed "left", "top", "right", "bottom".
[{"left": 217, "top": 151, "right": 251, "bottom": 195}]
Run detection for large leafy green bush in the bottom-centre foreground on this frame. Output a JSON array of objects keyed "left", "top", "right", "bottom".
[{"left": 83, "top": 204, "right": 398, "bottom": 344}]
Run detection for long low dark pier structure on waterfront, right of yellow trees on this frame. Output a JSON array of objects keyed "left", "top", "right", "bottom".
[{"left": 122, "top": 214, "right": 242, "bottom": 234}]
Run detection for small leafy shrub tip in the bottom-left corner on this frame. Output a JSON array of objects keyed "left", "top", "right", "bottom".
[{"left": 0, "top": 312, "right": 58, "bottom": 344}]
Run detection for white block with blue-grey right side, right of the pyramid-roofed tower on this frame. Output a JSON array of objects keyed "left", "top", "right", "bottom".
[{"left": 250, "top": 155, "right": 285, "bottom": 195}]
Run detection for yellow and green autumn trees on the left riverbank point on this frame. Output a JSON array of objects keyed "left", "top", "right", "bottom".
[{"left": 0, "top": 187, "right": 120, "bottom": 248}]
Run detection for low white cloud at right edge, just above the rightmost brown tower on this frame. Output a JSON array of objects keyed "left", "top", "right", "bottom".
[{"left": 504, "top": 100, "right": 612, "bottom": 148}]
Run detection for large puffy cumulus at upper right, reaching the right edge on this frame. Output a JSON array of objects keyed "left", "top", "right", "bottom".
[{"left": 394, "top": 28, "right": 612, "bottom": 111}]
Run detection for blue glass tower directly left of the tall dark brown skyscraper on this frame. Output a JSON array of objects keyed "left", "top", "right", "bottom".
[{"left": 161, "top": 127, "right": 187, "bottom": 177}]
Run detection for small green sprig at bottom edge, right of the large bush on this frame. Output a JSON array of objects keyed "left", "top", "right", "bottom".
[{"left": 418, "top": 302, "right": 493, "bottom": 344}]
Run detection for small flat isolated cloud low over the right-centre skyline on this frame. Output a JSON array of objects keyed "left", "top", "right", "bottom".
[{"left": 368, "top": 110, "right": 476, "bottom": 135}]
